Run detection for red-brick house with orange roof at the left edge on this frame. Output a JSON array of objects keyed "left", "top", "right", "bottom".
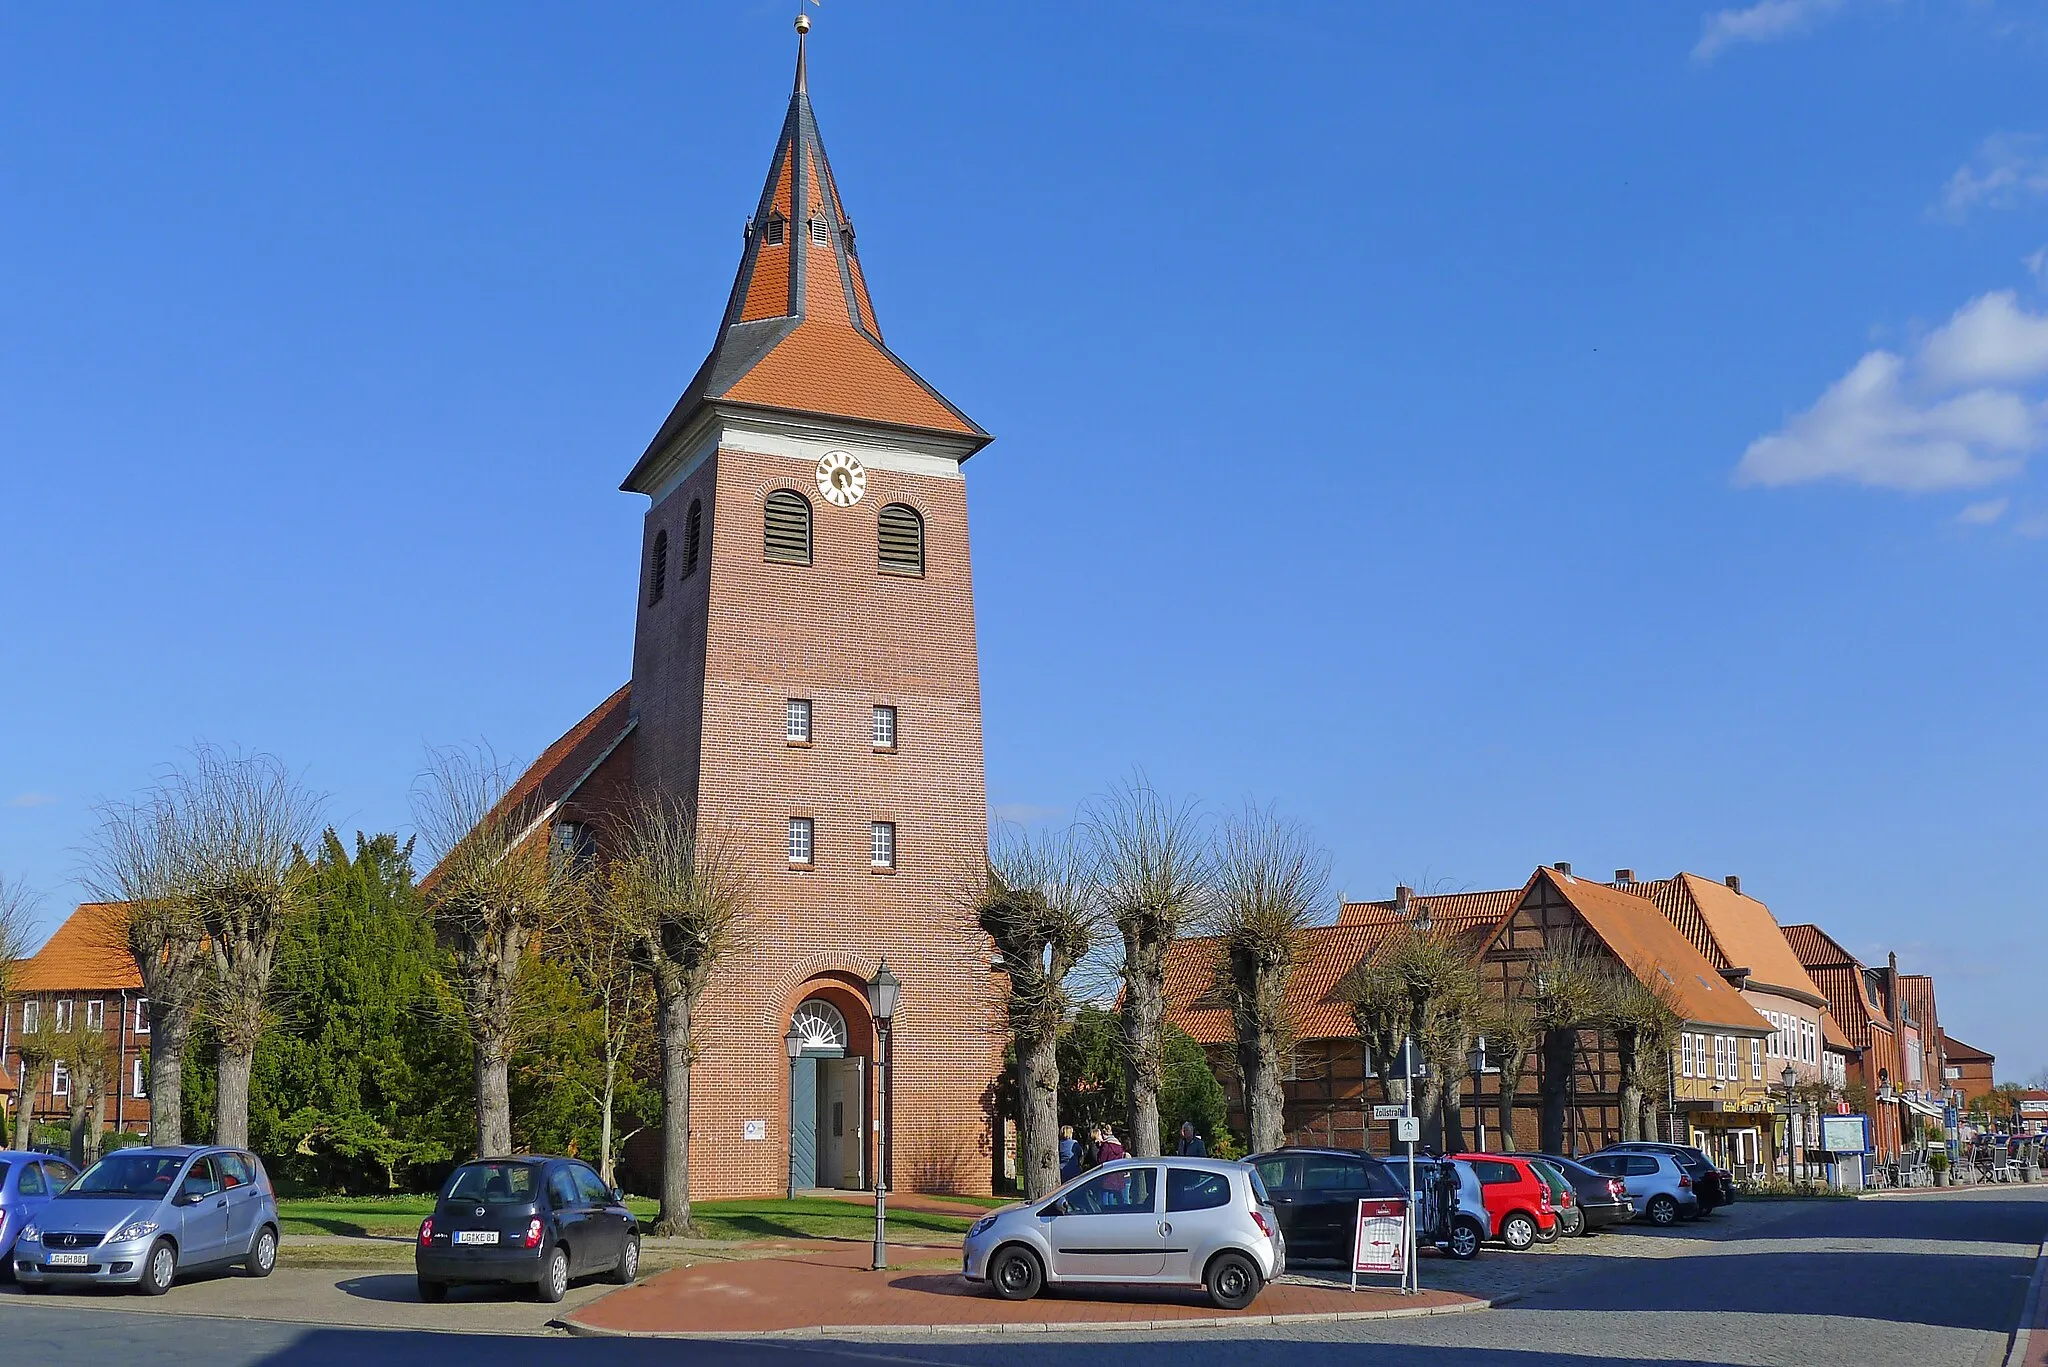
[{"left": 0, "top": 902, "right": 150, "bottom": 1131}]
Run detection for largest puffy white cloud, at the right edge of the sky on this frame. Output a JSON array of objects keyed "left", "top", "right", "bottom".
[{"left": 1735, "top": 291, "right": 2048, "bottom": 492}]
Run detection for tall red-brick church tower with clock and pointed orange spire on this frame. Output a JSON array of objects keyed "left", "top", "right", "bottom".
[{"left": 623, "top": 25, "right": 999, "bottom": 1197}]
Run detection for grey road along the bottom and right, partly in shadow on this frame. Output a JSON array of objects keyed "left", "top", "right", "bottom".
[{"left": 0, "top": 1187, "right": 2048, "bottom": 1367}]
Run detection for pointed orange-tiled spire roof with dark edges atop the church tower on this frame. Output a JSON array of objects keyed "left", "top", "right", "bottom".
[{"left": 621, "top": 14, "right": 989, "bottom": 492}]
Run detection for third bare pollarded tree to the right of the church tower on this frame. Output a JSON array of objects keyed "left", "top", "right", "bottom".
[{"left": 1208, "top": 807, "right": 1329, "bottom": 1152}]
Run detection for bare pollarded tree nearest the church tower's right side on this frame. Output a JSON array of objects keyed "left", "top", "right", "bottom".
[{"left": 971, "top": 830, "right": 1102, "bottom": 1199}]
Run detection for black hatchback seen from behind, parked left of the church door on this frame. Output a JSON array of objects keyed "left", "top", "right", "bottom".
[{"left": 414, "top": 1158, "right": 639, "bottom": 1301}]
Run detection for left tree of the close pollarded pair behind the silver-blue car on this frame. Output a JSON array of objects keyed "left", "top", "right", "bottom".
[{"left": 82, "top": 785, "right": 213, "bottom": 1146}]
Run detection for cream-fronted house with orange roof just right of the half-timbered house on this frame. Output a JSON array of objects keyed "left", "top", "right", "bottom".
[{"left": 1614, "top": 869, "right": 1829, "bottom": 1174}]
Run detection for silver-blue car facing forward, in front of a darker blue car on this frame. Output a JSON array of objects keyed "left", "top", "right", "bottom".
[{"left": 10, "top": 1146, "right": 279, "bottom": 1295}]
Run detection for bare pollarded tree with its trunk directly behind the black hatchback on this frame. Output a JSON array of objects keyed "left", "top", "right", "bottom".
[{"left": 414, "top": 748, "right": 582, "bottom": 1158}]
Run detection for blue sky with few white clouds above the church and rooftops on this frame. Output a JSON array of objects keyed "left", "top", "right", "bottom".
[{"left": 0, "top": 0, "right": 2048, "bottom": 1078}]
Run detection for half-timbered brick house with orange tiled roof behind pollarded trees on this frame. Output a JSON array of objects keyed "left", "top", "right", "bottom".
[{"left": 1167, "top": 865, "right": 1769, "bottom": 1152}]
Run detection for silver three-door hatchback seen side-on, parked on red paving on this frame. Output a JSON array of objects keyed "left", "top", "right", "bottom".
[{"left": 961, "top": 1158, "right": 1286, "bottom": 1310}]
